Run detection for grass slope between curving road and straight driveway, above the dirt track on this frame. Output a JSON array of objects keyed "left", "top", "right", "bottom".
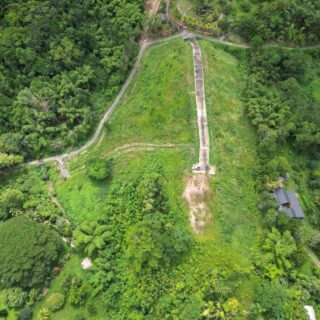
[{"left": 101, "top": 39, "right": 197, "bottom": 149}]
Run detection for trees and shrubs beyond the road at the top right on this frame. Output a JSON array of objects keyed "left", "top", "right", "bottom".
[{"left": 171, "top": 0, "right": 320, "bottom": 45}]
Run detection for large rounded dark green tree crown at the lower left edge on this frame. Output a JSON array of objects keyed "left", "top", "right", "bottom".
[{"left": 0, "top": 217, "right": 62, "bottom": 288}]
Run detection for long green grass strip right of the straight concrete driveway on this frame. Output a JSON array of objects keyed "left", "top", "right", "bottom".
[{"left": 200, "top": 40, "right": 262, "bottom": 261}]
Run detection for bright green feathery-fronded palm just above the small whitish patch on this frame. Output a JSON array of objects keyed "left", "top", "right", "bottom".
[{"left": 73, "top": 221, "right": 111, "bottom": 257}]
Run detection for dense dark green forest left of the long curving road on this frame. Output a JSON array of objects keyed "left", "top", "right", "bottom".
[{"left": 0, "top": 0, "right": 143, "bottom": 168}]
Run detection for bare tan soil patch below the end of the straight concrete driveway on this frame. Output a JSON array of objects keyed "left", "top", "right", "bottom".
[{"left": 183, "top": 174, "right": 211, "bottom": 234}]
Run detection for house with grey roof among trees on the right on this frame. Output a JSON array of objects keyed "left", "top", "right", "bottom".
[{"left": 273, "top": 188, "right": 304, "bottom": 219}]
